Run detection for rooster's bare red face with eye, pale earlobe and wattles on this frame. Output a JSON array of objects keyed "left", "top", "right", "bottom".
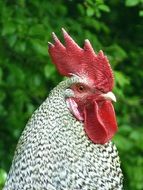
[{"left": 66, "top": 83, "right": 117, "bottom": 144}]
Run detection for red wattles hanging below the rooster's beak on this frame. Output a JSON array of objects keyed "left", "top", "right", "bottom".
[{"left": 84, "top": 100, "right": 118, "bottom": 144}]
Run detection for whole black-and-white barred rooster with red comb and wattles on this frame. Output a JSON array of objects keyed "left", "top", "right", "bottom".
[{"left": 3, "top": 29, "right": 123, "bottom": 190}]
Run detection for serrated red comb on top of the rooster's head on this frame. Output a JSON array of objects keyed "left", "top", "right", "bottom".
[{"left": 49, "top": 29, "right": 114, "bottom": 91}]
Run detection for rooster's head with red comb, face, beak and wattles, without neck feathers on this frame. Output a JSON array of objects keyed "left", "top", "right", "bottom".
[{"left": 49, "top": 29, "right": 117, "bottom": 144}]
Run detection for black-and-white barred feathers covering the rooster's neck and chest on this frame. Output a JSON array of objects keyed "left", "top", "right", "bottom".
[{"left": 3, "top": 77, "right": 123, "bottom": 190}]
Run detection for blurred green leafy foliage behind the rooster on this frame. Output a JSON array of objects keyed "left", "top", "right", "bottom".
[{"left": 0, "top": 0, "right": 143, "bottom": 190}]
